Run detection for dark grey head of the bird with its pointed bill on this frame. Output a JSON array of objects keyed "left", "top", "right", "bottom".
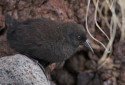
[{"left": 62, "top": 22, "right": 94, "bottom": 54}]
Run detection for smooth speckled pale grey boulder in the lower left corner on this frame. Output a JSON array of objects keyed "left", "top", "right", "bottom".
[{"left": 0, "top": 54, "right": 50, "bottom": 85}]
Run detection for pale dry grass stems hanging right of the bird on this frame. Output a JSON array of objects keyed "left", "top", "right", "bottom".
[{"left": 86, "top": 0, "right": 125, "bottom": 69}]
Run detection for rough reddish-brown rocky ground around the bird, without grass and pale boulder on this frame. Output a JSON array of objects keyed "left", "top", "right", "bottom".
[{"left": 0, "top": 0, "right": 125, "bottom": 85}]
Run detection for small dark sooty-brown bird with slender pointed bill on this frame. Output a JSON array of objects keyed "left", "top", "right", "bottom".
[{"left": 5, "top": 14, "right": 93, "bottom": 67}]
